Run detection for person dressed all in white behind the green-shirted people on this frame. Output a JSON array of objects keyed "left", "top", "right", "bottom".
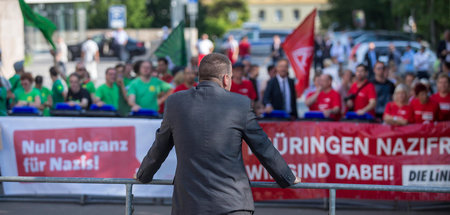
[{"left": 81, "top": 37, "right": 100, "bottom": 81}]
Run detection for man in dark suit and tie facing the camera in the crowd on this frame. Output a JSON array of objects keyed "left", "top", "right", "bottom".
[{"left": 263, "top": 59, "right": 297, "bottom": 119}]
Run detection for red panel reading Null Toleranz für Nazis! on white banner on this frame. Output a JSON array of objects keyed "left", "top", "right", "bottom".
[{"left": 14, "top": 126, "right": 139, "bottom": 178}]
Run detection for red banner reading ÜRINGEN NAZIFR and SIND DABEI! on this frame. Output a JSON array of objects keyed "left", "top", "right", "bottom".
[{"left": 243, "top": 122, "right": 450, "bottom": 201}]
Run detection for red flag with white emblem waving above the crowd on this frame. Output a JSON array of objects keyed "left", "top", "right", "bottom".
[{"left": 282, "top": 9, "right": 316, "bottom": 97}]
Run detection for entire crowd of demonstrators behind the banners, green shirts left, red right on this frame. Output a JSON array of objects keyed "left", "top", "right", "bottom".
[{"left": 0, "top": 29, "right": 450, "bottom": 125}]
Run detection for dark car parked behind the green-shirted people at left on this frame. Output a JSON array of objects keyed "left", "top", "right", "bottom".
[{"left": 67, "top": 34, "right": 146, "bottom": 61}]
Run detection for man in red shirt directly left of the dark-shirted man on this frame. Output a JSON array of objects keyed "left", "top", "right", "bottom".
[{"left": 346, "top": 64, "right": 377, "bottom": 117}]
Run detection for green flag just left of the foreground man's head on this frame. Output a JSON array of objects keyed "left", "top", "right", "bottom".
[{"left": 155, "top": 21, "right": 187, "bottom": 66}]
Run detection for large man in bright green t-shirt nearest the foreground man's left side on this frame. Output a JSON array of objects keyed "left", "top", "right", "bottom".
[{"left": 128, "top": 61, "right": 173, "bottom": 111}]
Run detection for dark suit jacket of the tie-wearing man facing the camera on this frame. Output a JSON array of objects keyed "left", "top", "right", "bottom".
[{"left": 263, "top": 77, "right": 297, "bottom": 118}]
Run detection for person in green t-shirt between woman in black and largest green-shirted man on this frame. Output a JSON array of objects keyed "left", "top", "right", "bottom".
[{"left": 94, "top": 68, "right": 121, "bottom": 110}]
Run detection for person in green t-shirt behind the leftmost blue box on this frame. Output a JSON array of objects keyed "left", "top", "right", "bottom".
[{"left": 14, "top": 72, "right": 41, "bottom": 108}]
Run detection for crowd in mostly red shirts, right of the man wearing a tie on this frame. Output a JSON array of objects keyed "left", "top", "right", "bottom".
[{"left": 304, "top": 31, "right": 450, "bottom": 125}]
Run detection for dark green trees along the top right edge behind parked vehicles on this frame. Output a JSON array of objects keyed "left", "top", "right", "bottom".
[{"left": 321, "top": 0, "right": 450, "bottom": 48}]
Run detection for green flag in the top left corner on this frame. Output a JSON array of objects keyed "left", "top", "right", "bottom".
[{"left": 19, "top": 0, "right": 56, "bottom": 49}]
